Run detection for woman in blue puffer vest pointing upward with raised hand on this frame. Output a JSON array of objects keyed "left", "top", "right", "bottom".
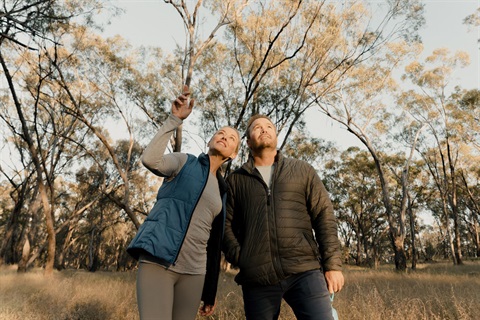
[{"left": 127, "top": 86, "right": 240, "bottom": 320}]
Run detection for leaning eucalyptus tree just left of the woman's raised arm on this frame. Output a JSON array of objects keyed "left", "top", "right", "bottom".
[{"left": 45, "top": 28, "right": 167, "bottom": 227}]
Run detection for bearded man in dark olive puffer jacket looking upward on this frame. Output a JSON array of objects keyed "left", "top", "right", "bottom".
[{"left": 224, "top": 115, "right": 344, "bottom": 320}]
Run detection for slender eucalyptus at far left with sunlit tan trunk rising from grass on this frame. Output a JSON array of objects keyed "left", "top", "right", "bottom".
[{"left": 0, "top": 41, "right": 90, "bottom": 274}]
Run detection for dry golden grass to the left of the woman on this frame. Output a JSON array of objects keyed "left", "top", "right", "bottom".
[{"left": 0, "top": 268, "right": 138, "bottom": 320}]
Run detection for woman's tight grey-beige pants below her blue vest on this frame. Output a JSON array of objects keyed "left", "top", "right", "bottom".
[{"left": 137, "top": 262, "right": 205, "bottom": 320}]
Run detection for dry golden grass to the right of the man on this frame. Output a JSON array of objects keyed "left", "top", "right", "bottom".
[{"left": 335, "top": 262, "right": 480, "bottom": 320}]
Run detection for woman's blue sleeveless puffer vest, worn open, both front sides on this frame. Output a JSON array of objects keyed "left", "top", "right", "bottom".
[{"left": 127, "top": 153, "right": 227, "bottom": 306}]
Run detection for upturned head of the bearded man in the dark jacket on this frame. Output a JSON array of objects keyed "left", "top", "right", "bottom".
[{"left": 247, "top": 118, "right": 277, "bottom": 151}]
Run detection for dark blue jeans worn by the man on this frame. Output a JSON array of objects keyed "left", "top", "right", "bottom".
[{"left": 242, "top": 270, "right": 333, "bottom": 320}]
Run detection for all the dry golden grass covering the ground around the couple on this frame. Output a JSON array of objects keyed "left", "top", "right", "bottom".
[{"left": 0, "top": 262, "right": 480, "bottom": 320}]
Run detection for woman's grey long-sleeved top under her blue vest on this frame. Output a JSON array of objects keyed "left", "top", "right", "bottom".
[{"left": 140, "top": 115, "right": 222, "bottom": 274}]
